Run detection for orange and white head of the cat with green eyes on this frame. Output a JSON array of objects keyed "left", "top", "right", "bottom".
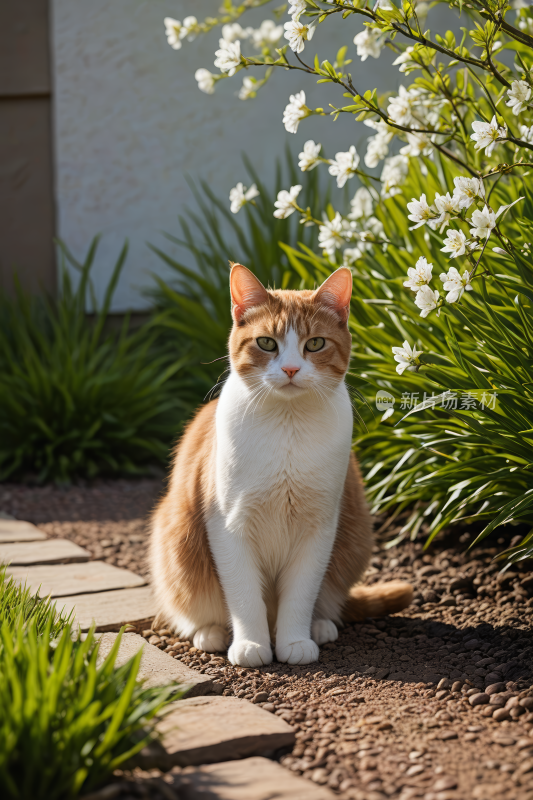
[{"left": 229, "top": 264, "right": 352, "bottom": 399}]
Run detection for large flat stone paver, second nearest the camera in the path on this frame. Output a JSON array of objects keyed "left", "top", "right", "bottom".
[{"left": 158, "top": 697, "right": 295, "bottom": 766}]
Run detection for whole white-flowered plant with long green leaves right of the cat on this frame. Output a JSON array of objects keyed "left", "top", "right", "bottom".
[{"left": 160, "top": 0, "right": 533, "bottom": 559}]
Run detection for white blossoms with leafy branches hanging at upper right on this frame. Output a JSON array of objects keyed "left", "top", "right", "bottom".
[{"left": 165, "top": 0, "right": 533, "bottom": 388}]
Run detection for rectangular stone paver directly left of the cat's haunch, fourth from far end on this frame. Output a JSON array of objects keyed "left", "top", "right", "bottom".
[{"left": 57, "top": 586, "right": 157, "bottom": 631}]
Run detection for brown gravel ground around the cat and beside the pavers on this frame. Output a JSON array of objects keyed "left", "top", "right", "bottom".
[{"left": 0, "top": 480, "right": 533, "bottom": 800}]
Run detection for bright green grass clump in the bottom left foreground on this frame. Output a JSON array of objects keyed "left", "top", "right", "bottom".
[{"left": 0, "top": 617, "right": 176, "bottom": 800}]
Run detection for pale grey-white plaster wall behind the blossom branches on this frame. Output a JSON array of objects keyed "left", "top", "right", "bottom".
[{"left": 52, "top": 0, "right": 390, "bottom": 311}]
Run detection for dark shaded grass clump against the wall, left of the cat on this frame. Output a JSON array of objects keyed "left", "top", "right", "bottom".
[{"left": 0, "top": 239, "right": 193, "bottom": 481}]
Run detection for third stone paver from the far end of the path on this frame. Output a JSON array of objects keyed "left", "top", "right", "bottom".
[{"left": 7, "top": 560, "right": 146, "bottom": 597}]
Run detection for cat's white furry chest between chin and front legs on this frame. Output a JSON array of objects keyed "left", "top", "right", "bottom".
[{"left": 215, "top": 376, "right": 352, "bottom": 535}]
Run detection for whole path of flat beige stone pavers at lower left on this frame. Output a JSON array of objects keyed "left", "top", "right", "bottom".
[{"left": 0, "top": 518, "right": 316, "bottom": 800}]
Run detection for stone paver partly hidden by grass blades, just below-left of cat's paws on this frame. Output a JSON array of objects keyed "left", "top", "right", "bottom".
[{"left": 98, "top": 633, "right": 212, "bottom": 696}]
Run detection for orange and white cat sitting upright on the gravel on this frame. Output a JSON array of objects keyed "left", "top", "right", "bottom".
[{"left": 150, "top": 264, "right": 413, "bottom": 667}]
